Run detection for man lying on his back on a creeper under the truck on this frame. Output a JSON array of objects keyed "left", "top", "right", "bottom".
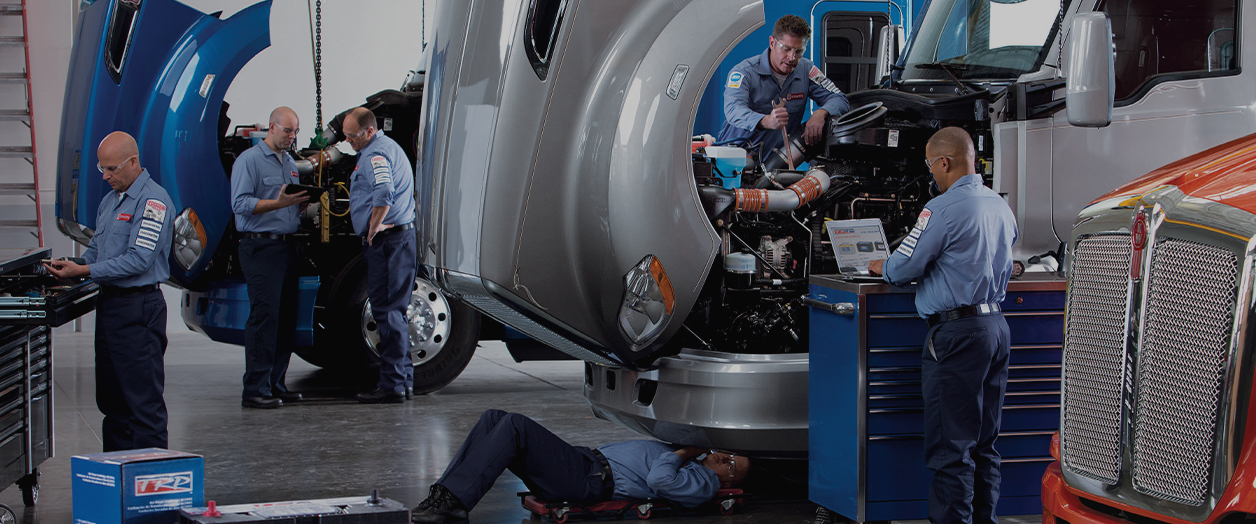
[{"left": 411, "top": 410, "right": 750, "bottom": 524}]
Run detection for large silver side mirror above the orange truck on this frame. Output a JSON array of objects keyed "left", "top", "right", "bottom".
[{"left": 1064, "top": 13, "right": 1117, "bottom": 127}]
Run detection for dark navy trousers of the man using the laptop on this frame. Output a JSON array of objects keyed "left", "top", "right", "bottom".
[{"left": 921, "top": 313, "right": 1011, "bottom": 524}]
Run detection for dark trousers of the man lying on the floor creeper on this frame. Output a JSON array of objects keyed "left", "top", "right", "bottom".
[{"left": 436, "top": 410, "right": 610, "bottom": 509}]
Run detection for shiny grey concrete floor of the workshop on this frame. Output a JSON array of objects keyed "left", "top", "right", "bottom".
[{"left": 0, "top": 324, "right": 1040, "bottom": 524}]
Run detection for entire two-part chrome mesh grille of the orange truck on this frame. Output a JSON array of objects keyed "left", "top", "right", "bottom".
[{"left": 1060, "top": 228, "right": 1238, "bottom": 506}]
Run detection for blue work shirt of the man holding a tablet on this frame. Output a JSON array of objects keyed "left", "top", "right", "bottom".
[{"left": 231, "top": 142, "right": 301, "bottom": 235}]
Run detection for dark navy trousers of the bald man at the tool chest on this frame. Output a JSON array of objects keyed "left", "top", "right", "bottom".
[{"left": 95, "top": 290, "right": 168, "bottom": 451}]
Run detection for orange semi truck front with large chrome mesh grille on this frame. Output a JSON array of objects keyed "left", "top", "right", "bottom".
[{"left": 1042, "top": 129, "right": 1256, "bottom": 517}]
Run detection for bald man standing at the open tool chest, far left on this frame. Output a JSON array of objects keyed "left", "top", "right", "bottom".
[{"left": 46, "top": 131, "right": 175, "bottom": 451}]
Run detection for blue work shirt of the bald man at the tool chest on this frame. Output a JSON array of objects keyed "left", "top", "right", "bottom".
[{"left": 83, "top": 170, "right": 175, "bottom": 288}]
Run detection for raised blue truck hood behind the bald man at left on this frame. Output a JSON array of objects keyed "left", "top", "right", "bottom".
[{"left": 57, "top": 0, "right": 271, "bottom": 287}]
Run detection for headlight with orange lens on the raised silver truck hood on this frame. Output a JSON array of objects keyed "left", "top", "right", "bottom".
[{"left": 619, "top": 255, "right": 676, "bottom": 351}]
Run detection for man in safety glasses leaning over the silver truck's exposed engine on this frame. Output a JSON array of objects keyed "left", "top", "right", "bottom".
[{"left": 717, "top": 15, "right": 850, "bottom": 161}]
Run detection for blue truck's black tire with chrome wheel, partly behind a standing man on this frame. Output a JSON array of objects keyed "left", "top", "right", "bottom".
[{"left": 299, "top": 258, "right": 480, "bottom": 395}]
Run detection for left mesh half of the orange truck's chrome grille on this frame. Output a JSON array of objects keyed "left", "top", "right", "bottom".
[{"left": 1060, "top": 234, "right": 1130, "bottom": 484}]
